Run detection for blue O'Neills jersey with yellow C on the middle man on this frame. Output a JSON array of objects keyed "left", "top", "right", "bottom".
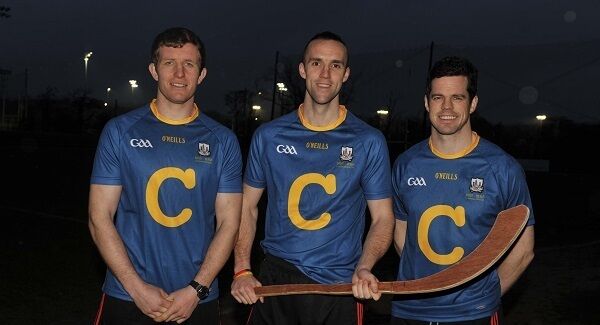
[{"left": 244, "top": 106, "right": 392, "bottom": 283}]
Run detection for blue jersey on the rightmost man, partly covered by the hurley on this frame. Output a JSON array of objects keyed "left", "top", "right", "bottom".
[{"left": 392, "top": 133, "right": 534, "bottom": 322}]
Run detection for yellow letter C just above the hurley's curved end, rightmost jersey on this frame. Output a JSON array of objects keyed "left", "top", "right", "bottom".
[{"left": 417, "top": 205, "right": 465, "bottom": 265}]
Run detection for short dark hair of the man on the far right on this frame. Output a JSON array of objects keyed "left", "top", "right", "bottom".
[{"left": 425, "top": 56, "right": 478, "bottom": 100}]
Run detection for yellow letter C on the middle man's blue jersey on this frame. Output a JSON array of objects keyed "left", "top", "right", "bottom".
[{"left": 288, "top": 173, "right": 336, "bottom": 230}]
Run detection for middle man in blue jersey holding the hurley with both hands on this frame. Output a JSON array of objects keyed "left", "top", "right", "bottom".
[{"left": 231, "top": 32, "right": 394, "bottom": 324}]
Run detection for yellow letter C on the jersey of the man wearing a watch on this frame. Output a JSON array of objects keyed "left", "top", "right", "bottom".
[{"left": 146, "top": 167, "right": 196, "bottom": 228}]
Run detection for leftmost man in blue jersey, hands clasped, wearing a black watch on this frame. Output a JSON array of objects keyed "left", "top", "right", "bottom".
[{"left": 89, "top": 28, "right": 242, "bottom": 325}]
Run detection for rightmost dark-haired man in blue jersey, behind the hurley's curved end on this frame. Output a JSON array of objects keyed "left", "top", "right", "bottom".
[{"left": 391, "top": 57, "right": 535, "bottom": 325}]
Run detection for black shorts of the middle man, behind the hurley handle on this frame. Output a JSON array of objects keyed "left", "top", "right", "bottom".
[{"left": 248, "top": 254, "right": 363, "bottom": 325}]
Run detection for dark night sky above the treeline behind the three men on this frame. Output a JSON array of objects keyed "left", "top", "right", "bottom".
[{"left": 0, "top": 0, "right": 600, "bottom": 123}]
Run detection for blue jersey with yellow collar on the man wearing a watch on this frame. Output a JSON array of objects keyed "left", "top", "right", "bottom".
[{"left": 91, "top": 101, "right": 242, "bottom": 301}]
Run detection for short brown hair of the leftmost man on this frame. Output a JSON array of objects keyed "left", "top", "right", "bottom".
[{"left": 150, "top": 27, "right": 206, "bottom": 70}]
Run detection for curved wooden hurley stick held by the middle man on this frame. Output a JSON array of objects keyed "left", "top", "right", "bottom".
[{"left": 254, "top": 205, "right": 529, "bottom": 297}]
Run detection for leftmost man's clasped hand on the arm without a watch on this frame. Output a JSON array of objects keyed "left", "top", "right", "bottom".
[{"left": 129, "top": 282, "right": 172, "bottom": 319}]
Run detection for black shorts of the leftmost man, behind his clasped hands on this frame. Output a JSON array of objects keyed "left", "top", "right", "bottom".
[{"left": 94, "top": 294, "right": 219, "bottom": 325}]
